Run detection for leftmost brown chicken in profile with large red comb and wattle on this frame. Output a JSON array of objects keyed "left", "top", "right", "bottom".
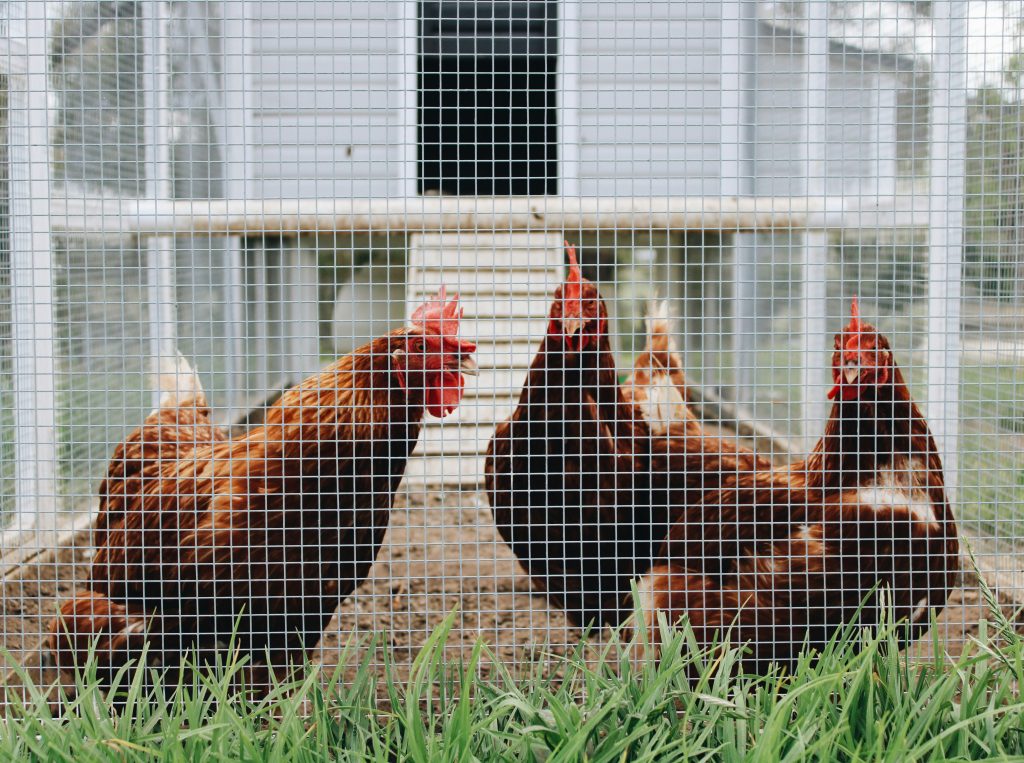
[{"left": 49, "top": 289, "right": 476, "bottom": 688}]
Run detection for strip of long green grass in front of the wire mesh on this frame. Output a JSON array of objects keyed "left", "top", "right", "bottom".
[{"left": 6, "top": 581, "right": 1024, "bottom": 763}]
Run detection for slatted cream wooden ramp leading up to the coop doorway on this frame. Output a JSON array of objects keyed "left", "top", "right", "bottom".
[{"left": 406, "top": 232, "right": 564, "bottom": 485}]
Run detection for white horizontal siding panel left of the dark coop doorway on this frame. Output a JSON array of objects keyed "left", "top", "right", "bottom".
[{"left": 247, "top": 0, "right": 410, "bottom": 198}]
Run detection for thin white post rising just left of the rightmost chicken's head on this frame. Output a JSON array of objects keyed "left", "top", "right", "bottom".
[{"left": 800, "top": 0, "right": 830, "bottom": 450}]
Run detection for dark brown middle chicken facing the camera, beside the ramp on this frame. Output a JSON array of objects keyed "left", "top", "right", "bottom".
[{"left": 484, "top": 242, "right": 651, "bottom": 625}]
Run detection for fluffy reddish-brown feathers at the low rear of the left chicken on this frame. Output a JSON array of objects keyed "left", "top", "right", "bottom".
[{"left": 48, "top": 591, "right": 148, "bottom": 685}]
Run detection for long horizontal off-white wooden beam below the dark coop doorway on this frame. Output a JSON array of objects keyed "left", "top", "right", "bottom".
[{"left": 51, "top": 197, "right": 930, "bottom": 238}]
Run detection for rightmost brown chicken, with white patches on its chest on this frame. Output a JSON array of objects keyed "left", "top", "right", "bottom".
[{"left": 638, "top": 301, "right": 959, "bottom": 673}]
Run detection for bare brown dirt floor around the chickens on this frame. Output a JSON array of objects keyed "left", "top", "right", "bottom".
[{"left": 0, "top": 491, "right": 1009, "bottom": 700}]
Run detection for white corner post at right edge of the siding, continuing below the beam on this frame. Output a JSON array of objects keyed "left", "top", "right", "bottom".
[{"left": 720, "top": 0, "right": 758, "bottom": 401}]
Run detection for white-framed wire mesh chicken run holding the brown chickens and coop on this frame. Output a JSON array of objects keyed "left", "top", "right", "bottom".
[{"left": 0, "top": 0, "right": 1024, "bottom": 692}]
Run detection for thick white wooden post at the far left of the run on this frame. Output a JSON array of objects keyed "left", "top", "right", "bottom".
[{"left": 9, "top": 0, "right": 60, "bottom": 531}]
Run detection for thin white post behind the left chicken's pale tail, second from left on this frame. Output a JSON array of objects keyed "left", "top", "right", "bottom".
[{"left": 142, "top": 0, "right": 178, "bottom": 407}]
